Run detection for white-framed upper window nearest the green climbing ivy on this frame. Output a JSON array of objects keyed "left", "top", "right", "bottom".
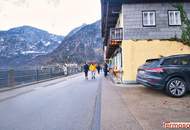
[{"left": 168, "top": 11, "right": 181, "bottom": 25}]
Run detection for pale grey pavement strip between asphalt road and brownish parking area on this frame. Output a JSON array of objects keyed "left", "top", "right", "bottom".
[{"left": 101, "top": 79, "right": 142, "bottom": 130}]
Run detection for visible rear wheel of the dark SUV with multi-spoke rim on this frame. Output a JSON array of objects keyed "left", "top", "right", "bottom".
[{"left": 166, "top": 78, "right": 187, "bottom": 97}]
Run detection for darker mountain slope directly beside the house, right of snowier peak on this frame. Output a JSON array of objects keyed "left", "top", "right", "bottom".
[{"left": 33, "top": 21, "right": 103, "bottom": 64}]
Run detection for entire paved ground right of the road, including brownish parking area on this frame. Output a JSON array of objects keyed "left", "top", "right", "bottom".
[{"left": 101, "top": 80, "right": 190, "bottom": 130}]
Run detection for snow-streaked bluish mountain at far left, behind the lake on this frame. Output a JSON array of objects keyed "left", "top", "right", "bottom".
[{"left": 0, "top": 26, "right": 64, "bottom": 66}]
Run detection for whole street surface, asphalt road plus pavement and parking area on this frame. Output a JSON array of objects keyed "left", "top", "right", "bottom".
[{"left": 0, "top": 74, "right": 190, "bottom": 130}]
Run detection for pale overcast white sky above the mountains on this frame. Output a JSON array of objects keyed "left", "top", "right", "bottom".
[{"left": 0, "top": 0, "right": 101, "bottom": 35}]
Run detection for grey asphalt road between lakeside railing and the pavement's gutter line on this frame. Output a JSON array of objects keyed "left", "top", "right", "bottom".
[{"left": 0, "top": 76, "right": 101, "bottom": 130}]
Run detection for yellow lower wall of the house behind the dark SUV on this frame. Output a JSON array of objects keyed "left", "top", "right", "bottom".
[{"left": 121, "top": 40, "right": 190, "bottom": 81}]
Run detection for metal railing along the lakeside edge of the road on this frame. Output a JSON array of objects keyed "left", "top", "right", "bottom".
[{"left": 0, "top": 67, "right": 81, "bottom": 88}]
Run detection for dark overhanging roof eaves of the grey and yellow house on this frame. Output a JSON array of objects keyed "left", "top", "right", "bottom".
[{"left": 101, "top": 0, "right": 190, "bottom": 45}]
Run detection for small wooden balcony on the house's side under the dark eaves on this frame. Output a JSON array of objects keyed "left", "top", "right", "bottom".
[{"left": 109, "top": 28, "right": 123, "bottom": 46}]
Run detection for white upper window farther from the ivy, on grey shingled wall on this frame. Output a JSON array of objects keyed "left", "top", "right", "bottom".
[{"left": 143, "top": 11, "right": 156, "bottom": 27}]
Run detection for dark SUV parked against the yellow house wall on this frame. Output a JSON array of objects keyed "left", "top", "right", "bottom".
[{"left": 137, "top": 54, "right": 190, "bottom": 97}]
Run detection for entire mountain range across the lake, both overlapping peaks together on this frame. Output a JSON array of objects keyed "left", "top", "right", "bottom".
[{"left": 0, "top": 21, "right": 103, "bottom": 68}]
